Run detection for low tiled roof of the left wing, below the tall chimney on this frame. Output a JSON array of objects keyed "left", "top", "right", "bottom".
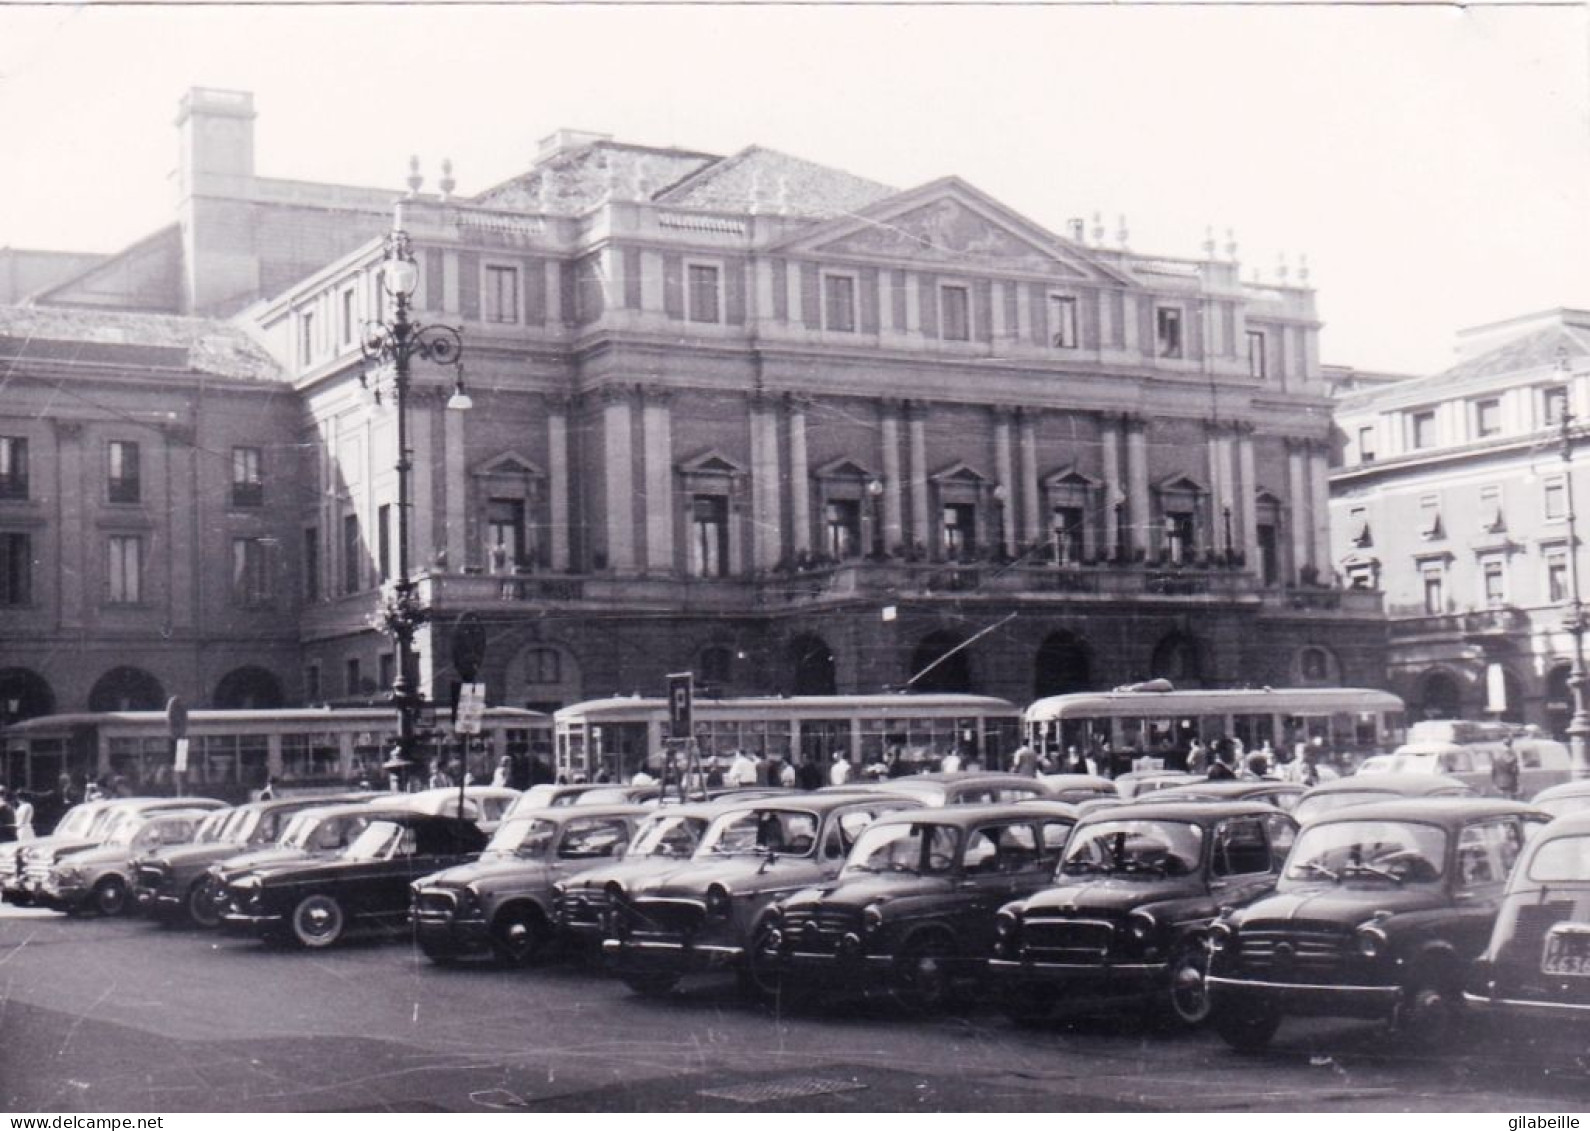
[{"left": 0, "top": 305, "right": 286, "bottom": 382}]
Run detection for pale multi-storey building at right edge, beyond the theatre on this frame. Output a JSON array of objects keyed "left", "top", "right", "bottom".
[{"left": 1331, "top": 310, "right": 1590, "bottom": 735}]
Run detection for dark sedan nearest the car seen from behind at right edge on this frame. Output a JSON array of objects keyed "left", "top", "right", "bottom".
[{"left": 1208, "top": 797, "right": 1547, "bottom": 1050}]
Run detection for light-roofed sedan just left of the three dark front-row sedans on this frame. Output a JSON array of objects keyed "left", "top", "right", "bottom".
[{"left": 603, "top": 791, "right": 922, "bottom": 994}]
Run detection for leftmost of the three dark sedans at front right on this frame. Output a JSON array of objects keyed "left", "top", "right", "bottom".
[{"left": 747, "top": 802, "right": 1076, "bottom": 1010}]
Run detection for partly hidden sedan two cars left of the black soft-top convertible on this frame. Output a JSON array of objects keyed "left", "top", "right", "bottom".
[{"left": 134, "top": 792, "right": 380, "bottom": 927}]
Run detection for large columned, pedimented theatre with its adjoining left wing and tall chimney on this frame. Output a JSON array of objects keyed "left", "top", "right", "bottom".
[{"left": 0, "top": 91, "right": 1385, "bottom": 744}]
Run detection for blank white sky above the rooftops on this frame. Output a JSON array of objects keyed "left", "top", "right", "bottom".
[{"left": 0, "top": 5, "right": 1590, "bottom": 372}]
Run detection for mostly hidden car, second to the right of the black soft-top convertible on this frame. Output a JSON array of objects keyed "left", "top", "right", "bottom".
[{"left": 552, "top": 799, "right": 755, "bottom": 943}]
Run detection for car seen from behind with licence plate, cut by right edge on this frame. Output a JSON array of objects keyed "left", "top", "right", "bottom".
[{"left": 1463, "top": 810, "right": 1590, "bottom": 1037}]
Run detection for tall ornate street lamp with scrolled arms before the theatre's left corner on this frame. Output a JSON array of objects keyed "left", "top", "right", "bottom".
[{"left": 359, "top": 202, "right": 472, "bottom": 784}]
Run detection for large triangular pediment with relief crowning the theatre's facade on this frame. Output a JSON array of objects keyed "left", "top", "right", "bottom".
[{"left": 771, "top": 177, "right": 1130, "bottom": 283}]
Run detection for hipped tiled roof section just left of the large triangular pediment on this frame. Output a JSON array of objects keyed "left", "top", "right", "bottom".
[{"left": 657, "top": 145, "right": 895, "bottom": 218}]
